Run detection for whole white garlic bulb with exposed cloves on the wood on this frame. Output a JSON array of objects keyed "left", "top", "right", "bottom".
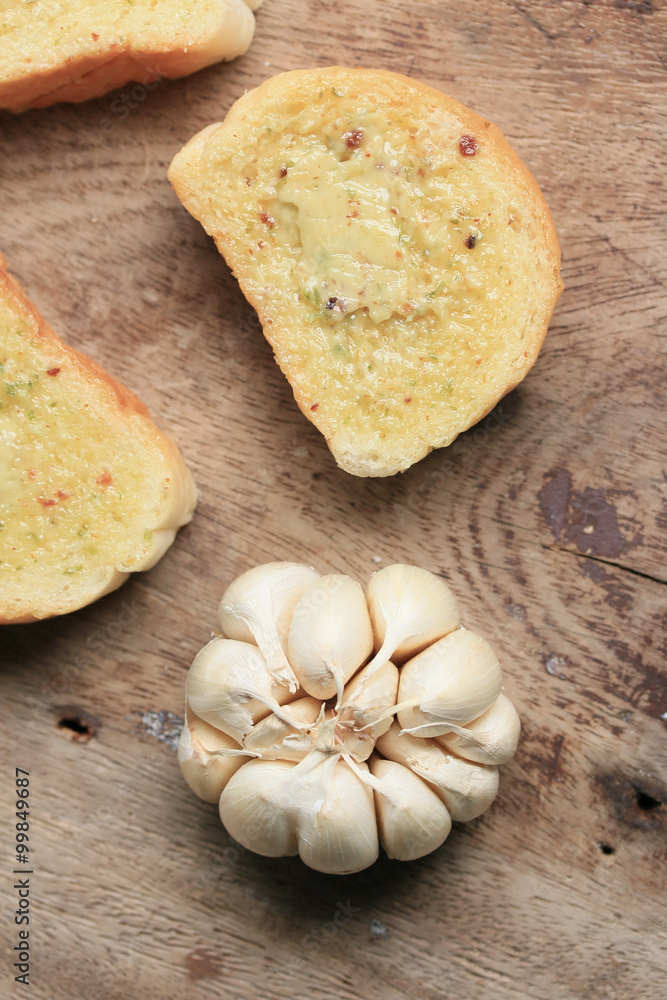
[{"left": 179, "top": 563, "right": 520, "bottom": 874}]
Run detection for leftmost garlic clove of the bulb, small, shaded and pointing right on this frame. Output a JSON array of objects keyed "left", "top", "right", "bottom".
[{"left": 178, "top": 707, "right": 249, "bottom": 802}]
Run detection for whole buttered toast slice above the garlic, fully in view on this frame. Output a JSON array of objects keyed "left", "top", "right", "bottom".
[{"left": 169, "top": 67, "right": 562, "bottom": 476}]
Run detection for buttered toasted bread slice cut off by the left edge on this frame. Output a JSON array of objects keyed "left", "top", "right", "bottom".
[{"left": 0, "top": 258, "right": 197, "bottom": 623}]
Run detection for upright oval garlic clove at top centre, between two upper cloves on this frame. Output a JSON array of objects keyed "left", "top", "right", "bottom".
[{"left": 288, "top": 574, "right": 373, "bottom": 702}]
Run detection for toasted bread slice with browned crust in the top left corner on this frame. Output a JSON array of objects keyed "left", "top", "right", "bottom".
[{"left": 0, "top": 0, "right": 261, "bottom": 111}]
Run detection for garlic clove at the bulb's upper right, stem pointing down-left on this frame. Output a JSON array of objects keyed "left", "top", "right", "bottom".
[{"left": 366, "top": 563, "right": 459, "bottom": 669}]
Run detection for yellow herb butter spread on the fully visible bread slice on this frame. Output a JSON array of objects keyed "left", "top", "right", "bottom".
[{"left": 222, "top": 107, "right": 532, "bottom": 428}]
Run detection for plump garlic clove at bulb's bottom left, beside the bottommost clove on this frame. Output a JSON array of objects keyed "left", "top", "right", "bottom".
[{"left": 220, "top": 760, "right": 298, "bottom": 858}]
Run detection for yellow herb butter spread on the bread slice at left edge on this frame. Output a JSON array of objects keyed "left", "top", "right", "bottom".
[{"left": 0, "top": 301, "right": 168, "bottom": 587}]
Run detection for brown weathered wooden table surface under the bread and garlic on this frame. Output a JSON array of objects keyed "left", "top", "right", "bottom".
[{"left": 0, "top": 0, "right": 667, "bottom": 1000}]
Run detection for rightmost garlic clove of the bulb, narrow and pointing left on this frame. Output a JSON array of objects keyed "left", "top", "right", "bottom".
[{"left": 435, "top": 692, "right": 521, "bottom": 764}]
